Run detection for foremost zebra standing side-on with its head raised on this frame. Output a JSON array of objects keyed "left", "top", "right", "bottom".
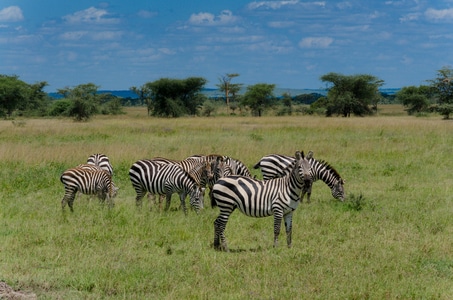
[{"left": 212, "top": 151, "right": 311, "bottom": 251}]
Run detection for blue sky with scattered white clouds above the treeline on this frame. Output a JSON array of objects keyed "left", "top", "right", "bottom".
[{"left": 0, "top": 0, "right": 453, "bottom": 91}]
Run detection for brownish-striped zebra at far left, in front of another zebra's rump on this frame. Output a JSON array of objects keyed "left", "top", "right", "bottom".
[{"left": 60, "top": 168, "right": 118, "bottom": 212}]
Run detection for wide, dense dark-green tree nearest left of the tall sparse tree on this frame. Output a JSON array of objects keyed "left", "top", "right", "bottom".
[{"left": 145, "top": 77, "right": 207, "bottom": 118}]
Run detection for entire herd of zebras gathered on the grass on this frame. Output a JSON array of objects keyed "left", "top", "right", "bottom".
[{"left": 60, "top": 151, "right": 345, "bottom": 251}]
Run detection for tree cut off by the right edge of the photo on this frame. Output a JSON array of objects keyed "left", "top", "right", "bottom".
[{"left": 428, "top": 67, "right": 453, "bottom": 119}]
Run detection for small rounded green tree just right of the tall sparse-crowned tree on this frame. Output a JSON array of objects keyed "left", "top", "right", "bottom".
[{"left": 242, "top": 83, "right": 275, "bottom": 117}]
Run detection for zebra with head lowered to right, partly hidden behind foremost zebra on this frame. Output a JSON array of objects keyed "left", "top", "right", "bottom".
[{"left": 253, "top": 151, "right": 345, "bottom": 203}]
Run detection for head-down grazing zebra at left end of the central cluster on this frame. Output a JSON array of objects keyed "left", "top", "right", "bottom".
[{"left": 129, "top": 159, "right": 203, "bottom": 215}]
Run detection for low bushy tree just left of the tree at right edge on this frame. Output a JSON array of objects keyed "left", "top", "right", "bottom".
[{"left": 396, "top": 85, "right": 432, "bottom": 115}]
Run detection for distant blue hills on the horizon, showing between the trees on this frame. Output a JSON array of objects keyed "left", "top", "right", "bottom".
[{"left": 48, "top": 88, "right": 399, "bottom": 99}]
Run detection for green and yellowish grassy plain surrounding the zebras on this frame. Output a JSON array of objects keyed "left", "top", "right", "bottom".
[{"left": 0, "top": 106, "right": 453, "bottom": 299}]
